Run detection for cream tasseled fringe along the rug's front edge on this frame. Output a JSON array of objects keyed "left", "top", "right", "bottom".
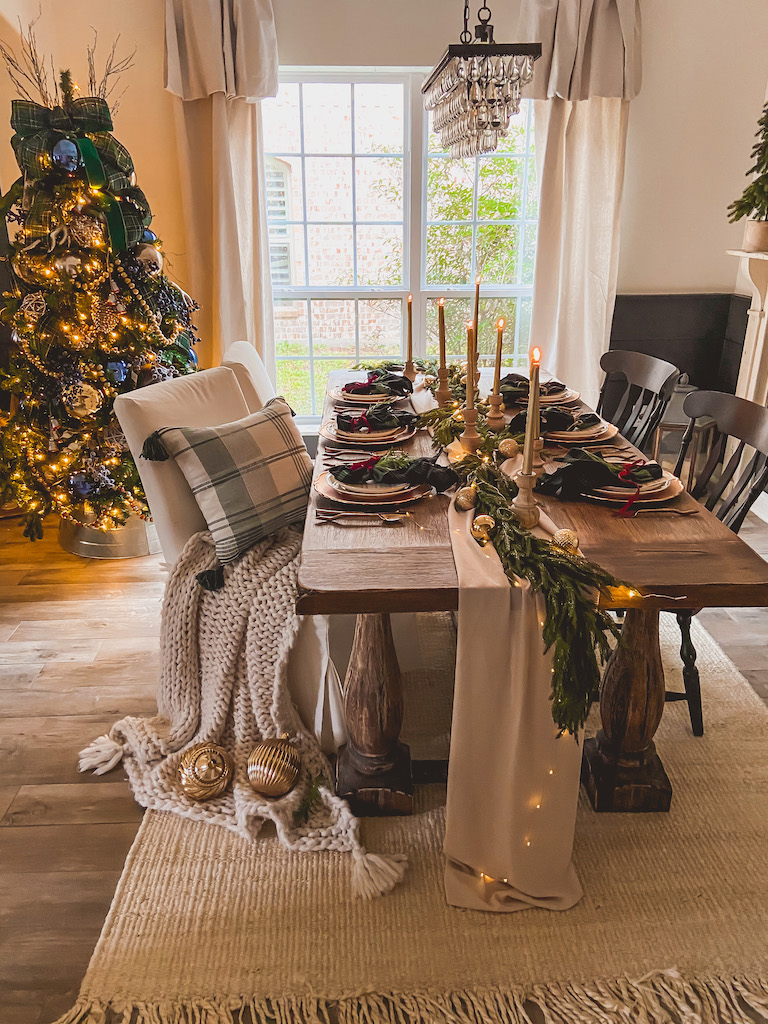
[{"left": 49, "top": 970, "right": 768, "bottom": 1024}]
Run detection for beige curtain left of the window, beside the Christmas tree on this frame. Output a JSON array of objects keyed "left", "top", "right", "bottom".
[{"left": 166, "top": 0, "right": 278, "bottom": 377}]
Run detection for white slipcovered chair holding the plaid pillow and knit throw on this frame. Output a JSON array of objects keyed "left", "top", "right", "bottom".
[{"left": 115, "top": 368, "right": 346, "bottom": 753}]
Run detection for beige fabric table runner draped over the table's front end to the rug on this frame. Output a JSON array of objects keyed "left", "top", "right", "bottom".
[{"left": 412, "top": 388, "right": 582, "bottom": 912}]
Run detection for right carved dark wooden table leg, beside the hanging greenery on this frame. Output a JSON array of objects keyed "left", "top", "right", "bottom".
[{"left": 582, "top": 608, "right": 672, "bottom": 811}]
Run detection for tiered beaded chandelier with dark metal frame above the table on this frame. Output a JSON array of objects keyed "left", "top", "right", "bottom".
[{"left": 421, "top": 0, "right": 542, "bottom": 158}]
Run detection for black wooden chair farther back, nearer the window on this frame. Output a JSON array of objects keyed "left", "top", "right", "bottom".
[{"left": 597, "top": 351, "right": 680, "bottom": 451}]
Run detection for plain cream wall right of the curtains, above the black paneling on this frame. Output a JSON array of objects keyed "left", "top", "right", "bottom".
[{"left": 618, "top": 0, "right": 768, "bottom": 292}]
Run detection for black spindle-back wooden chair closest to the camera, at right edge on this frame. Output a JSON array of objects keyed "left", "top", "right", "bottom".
[{"left": 667, "top": 391, "right": 768, "bottom": 736}]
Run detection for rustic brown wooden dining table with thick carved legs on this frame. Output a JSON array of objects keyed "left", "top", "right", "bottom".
[{"left": 297, "top": 371, "right": 768, "bottom": 815}]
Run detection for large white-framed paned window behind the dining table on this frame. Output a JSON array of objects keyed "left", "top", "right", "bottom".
[{"left": 262, "top": 72, "right": 537, "bottom": 418}]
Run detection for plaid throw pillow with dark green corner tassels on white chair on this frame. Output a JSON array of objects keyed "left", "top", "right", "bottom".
[{"left": 141, "top": 398, "right": 312, "bottom": 562}]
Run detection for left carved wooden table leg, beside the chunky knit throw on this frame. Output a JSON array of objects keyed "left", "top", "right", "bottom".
[{"left": 336, "top": 614, "right": 414, "bottom": 815}]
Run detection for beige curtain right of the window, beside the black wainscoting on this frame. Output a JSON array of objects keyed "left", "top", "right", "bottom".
[{"left": 518, "top": 0, "right": 641, "bottom": 404}]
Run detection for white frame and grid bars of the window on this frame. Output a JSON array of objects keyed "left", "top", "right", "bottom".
[{"left": 267, "top": 67, "right": 534, "bottom": 424}]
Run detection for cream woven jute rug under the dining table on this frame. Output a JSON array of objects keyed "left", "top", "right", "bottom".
[{"left": 57, "top": 615, "right": 768, "bottom": 1024}]
